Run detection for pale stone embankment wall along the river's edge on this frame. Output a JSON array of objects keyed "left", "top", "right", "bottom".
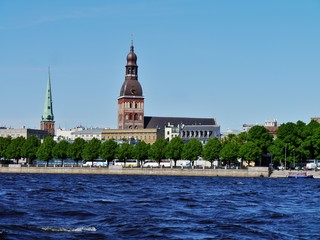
[{"left": 0, "top": 164, "right": 320, "bottom": 178}]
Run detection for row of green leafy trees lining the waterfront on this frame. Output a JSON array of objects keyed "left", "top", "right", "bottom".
[{"left": 0, "top": 121, "right": 320, "bottom": 166}]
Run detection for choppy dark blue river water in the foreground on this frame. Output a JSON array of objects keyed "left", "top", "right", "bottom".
[{"left": 0, "top": 174, "right": 320, "bottom": 240}]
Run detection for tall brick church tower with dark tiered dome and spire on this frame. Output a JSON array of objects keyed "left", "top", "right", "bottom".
[{"left": 118, "top": 42, "right": 144, "bottom": 129}]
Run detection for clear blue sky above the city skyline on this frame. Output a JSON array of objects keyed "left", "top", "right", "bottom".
[{"left": 0, "top": 0, "right": 320, "bottom": 131}]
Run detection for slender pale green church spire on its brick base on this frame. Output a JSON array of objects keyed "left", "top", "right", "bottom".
[{"left": 40, "top": 70, "right": 55, "bottom": 136}]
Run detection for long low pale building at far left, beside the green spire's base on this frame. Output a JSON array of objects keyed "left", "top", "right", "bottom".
[{"left": 0, "top": 128, "right": 49, "bottom": 140}]
